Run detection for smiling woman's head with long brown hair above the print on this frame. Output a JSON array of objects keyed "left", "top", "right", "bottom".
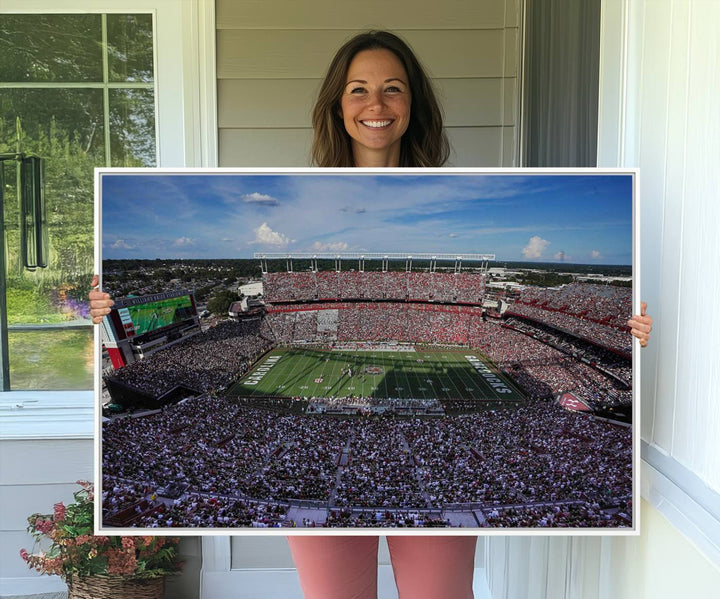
[{"left": 312, "top": 31, "right": 450, "bottom": 167}]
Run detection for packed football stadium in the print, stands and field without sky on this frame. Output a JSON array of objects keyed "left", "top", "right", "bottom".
[{"left": 102, "top": 254, "right": 633, "bottom": 528}]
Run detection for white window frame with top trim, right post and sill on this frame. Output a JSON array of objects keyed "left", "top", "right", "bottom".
[{"left": 0, "top": 0, "right": 217, "bottom": 439}]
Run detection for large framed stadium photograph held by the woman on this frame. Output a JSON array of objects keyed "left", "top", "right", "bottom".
[{"left": 96, "top": 169, "right": 638, "bottom": 534}]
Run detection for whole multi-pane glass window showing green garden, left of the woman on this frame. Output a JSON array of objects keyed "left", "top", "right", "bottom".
[{"left": 0, "top": 14, "right": 157, "bottom": 390}]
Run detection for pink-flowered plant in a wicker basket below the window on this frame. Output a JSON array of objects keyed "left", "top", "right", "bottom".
[{"left": 20, "top": 481, "right": 182, "bottom": 599}]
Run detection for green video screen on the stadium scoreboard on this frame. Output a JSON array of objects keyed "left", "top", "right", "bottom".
[{"left": 110, "top": 293, "right": 195, "bottom": 338}]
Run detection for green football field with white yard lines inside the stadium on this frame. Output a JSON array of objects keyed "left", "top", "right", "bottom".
[{"left": 231, "top": 347, "right": 523, "bottom": 401}]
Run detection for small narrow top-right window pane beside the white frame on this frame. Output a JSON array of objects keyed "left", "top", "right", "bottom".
[{"left": 107, "top": 14, "right": 153, "bottom": 83}]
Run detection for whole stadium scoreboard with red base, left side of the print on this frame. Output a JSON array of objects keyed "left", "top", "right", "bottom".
[{"left": 102, "top": 290, "right": 200, "bottom": 368}]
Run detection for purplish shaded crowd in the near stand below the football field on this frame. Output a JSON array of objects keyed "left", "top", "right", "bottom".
[{"left": 102, "top": 396, "right": 632, "bottom": 527}]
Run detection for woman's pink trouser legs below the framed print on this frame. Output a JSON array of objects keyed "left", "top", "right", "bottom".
[{"left": 288, "top": 536, "right": 477, "bottom": 599}]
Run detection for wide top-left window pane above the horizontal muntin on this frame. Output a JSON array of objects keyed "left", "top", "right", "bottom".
[{"left": 0, "top": 15, "right": 102, "bottom": 82}]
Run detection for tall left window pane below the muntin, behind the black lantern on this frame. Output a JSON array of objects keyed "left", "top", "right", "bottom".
[{"left": 0, "top": 89, "right": 98, "bottom": 390}]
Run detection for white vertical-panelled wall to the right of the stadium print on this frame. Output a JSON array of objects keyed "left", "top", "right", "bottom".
[{"left": 599, "top": 0, "right": 720, "bottom": 491}]
